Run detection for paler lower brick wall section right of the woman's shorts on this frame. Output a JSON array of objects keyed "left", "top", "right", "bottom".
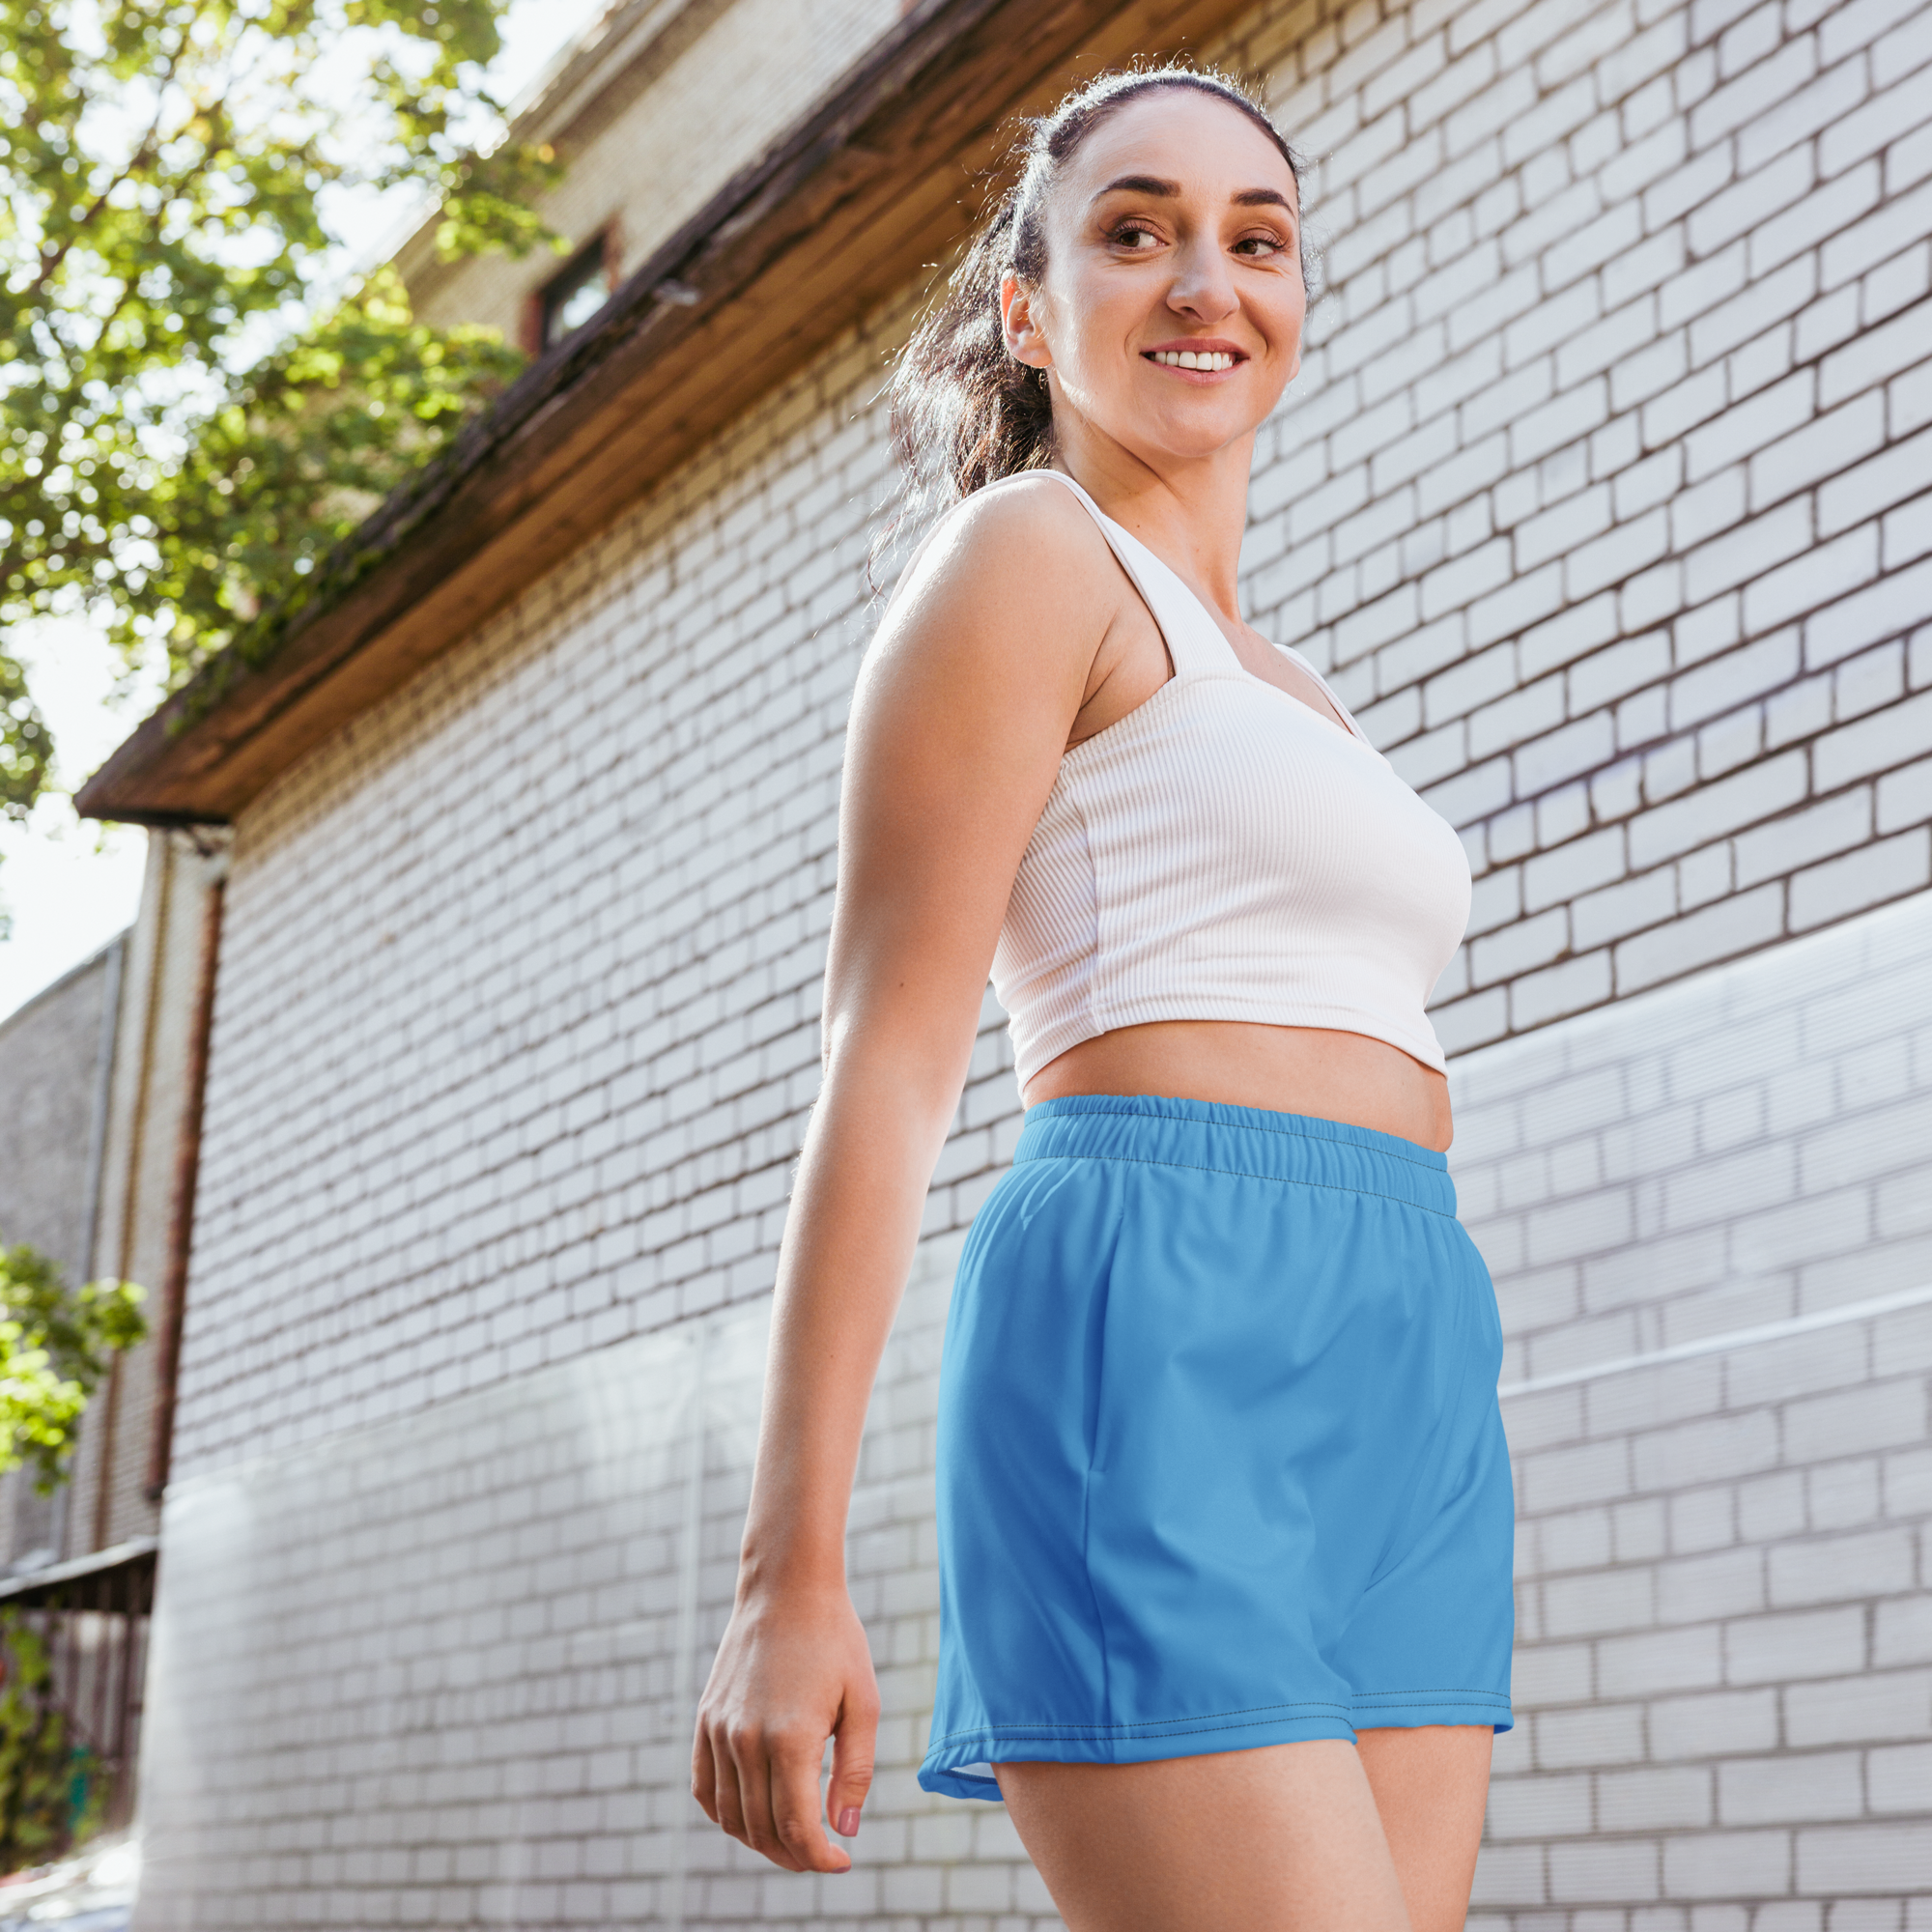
[{"left": 1453, "top": 895, "right": 1932, "bottom": 1932}]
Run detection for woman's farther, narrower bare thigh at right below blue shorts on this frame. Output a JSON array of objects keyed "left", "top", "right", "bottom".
[{"left": 1356, "top": 1723, "right": 1495, "bottom": 1932}]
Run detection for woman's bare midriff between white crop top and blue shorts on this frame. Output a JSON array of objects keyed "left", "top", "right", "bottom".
[{"left": 1020, "top": 1020, "right": 1453, "bottom": 1153}]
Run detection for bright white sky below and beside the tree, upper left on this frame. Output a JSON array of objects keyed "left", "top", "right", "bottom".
[{"left": 0, "top": 0, "right": 609, "bottom": 1018}]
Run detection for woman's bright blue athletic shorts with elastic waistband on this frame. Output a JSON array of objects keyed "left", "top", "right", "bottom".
[{"left": 920, "top": 1094, "right": 1515, "bottom": 1799}]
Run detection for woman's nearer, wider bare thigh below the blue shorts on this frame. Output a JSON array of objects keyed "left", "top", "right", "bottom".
[{"left": 995, "top": 1737, "right": 1408, "bottom": 1932}]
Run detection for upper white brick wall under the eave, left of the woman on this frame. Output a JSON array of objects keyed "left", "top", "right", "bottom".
[{"left": 176, "top": 294, "right": 947, "bottom": 1474}]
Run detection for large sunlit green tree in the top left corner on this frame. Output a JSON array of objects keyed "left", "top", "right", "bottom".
[{"left": 0, "top": 0, "right": 562, "bottom": 800}]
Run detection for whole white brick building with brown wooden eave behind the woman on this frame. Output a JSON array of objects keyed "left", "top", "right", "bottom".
[{"left": 85, "top": 0, "right": 1932, "bottom": 1932}]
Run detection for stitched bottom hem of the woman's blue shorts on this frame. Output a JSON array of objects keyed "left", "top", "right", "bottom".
[{"left": 918, "top": 1690, "right": 1515, "bottom": 1804}]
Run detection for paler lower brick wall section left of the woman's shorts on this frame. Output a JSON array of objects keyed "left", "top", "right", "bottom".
[{"left": 139, "top": 1235, "right": 1059, "bottom": 1932}]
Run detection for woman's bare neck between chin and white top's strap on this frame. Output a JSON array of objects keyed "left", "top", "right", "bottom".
[{"left": 1053, "top": 410, "right": 1254, "bottom": 622}]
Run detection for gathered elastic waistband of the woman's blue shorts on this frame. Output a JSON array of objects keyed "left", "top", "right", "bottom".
[{"left": 1012, "top": 1094, "right": 1455, "bottom": 1215}]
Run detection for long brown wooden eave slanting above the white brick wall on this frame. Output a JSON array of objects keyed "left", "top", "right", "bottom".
[{"left": 75, "top": 0, "right": 1246, "bottom": 825}]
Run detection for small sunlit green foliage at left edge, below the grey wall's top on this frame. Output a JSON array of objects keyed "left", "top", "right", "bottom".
[{"left": 0, "top": 1244, "right": 147, "bottom": 1493}]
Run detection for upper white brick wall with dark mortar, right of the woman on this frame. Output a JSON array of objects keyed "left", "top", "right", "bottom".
[{"left": 1233, "top": 0, "right": 1932, "bottom": 1049}]
